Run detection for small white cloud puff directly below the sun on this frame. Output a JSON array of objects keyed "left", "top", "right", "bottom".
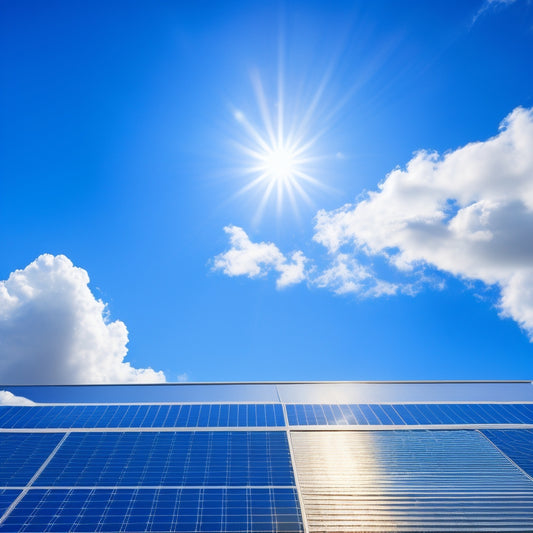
[{"left": 213, "top": 226, "right": 307, "bottom": 289}]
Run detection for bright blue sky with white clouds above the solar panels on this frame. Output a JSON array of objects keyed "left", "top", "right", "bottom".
[{"left": 0, "top": 0, "right": 533, "bottom": 383}]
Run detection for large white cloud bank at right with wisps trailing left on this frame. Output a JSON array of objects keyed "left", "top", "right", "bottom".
[{"left": 214, "top": 108, "right": 533, "bottom": 340}]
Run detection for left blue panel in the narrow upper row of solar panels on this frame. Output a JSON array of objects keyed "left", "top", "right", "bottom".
[{"left": 0, "top": 404, "right": 285, "bottom": 429}]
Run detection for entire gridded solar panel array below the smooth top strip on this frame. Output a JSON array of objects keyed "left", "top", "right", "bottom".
[{"left": 0, "top": 392, "right": 533, "bottom": 533}]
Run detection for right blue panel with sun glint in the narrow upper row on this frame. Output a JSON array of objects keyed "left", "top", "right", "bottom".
[{"left": 286, "top": 404, "right": 533, "bottom": 426}]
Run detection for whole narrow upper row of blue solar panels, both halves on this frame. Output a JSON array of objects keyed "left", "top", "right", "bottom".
[{"left": 0, "top": 404, "right": 533, "bottom": 429}]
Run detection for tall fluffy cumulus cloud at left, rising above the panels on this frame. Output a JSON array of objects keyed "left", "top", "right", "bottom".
[{"left": 0, "top": 254, "right": 165, "bottom": 384}]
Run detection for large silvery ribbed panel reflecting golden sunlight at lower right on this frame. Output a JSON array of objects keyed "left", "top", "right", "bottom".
[{"left": 291, "top": 430, "right": 533, "bottom": 532}]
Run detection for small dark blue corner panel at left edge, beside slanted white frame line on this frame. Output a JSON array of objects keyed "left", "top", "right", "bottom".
[{"left": 0, "top": 433, "right": 63, "bottom": 487}]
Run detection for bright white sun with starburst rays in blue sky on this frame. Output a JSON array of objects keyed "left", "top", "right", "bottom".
[{"left": 234, "top": 71, "right": 325, "bottom": 222}]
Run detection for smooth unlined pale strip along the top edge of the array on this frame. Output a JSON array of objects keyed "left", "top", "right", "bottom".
[{"left": 5, "top": 381, "right": 533, "bottom": 404}]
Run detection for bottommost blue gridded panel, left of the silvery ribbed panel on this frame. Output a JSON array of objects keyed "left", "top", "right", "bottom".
[{"left": 0, "top": 489, "right": 303, "bottom": 533}]
